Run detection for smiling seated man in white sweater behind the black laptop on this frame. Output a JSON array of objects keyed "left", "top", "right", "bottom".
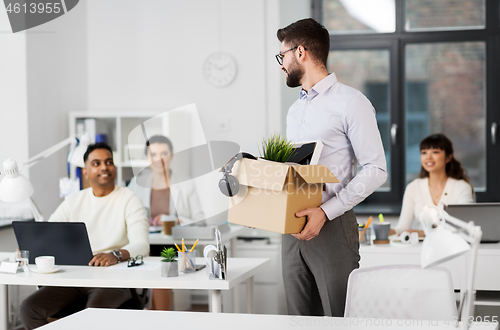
[{"left": 20, "top": 143, "right": 149, "bottom": 330}]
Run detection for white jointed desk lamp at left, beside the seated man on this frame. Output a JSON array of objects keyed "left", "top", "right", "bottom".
[{"left": 0, "top": 136, "right": 89, "bottom": 221}]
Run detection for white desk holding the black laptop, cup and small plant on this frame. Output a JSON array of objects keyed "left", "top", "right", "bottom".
[{"left": 0, "top": 257, "right": 269, "bottom": 330}]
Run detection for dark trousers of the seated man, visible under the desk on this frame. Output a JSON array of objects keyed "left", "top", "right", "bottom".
[{"left": 19, "top": 286, "right": 132, "bottom": 330}]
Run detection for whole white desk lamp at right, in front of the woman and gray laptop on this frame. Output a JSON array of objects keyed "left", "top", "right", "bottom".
[{"left": 420, "top": 206, "right": 483, "bottom": 329}]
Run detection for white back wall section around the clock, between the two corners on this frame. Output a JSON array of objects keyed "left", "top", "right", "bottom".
[{"left": 88, "top": 0, "right": 281, "bottom": 152}]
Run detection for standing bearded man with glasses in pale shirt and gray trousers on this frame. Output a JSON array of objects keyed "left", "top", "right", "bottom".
[{"left": 276, "top": 18, "right": 387, "bottom": 316}]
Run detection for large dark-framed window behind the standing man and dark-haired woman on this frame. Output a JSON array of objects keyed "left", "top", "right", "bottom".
[{"left": 313, "top": 0, "right": 500, "bottom": 214}]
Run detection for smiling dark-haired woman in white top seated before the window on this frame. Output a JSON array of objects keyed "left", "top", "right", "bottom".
[{"left": 391, "top": 134, "right": 475, "bottom": 236}]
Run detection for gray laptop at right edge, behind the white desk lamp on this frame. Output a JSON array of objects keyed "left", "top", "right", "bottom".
[{"left": 444, "top": 203, "right": 500, "bottom": 243}]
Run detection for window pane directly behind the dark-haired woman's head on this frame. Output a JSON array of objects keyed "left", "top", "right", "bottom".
[{"left": 405, "top": 41, "right": 486, "bottom": 188}]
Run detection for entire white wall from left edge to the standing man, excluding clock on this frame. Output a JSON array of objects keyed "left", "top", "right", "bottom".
[{"left": 0, "top": 0, "right": 310, "bottom": 222}]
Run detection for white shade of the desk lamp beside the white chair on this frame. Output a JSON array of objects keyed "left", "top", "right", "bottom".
[{"left": 420, "top": 227, "right": 470, "bottom": 268}]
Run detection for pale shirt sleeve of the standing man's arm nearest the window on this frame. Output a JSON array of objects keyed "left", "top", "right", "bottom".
[{"left": 321, "top": 92, "right": 387, "bottom": 220}]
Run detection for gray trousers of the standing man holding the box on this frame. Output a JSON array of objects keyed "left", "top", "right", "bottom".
[{"left": 281, "top": 210, "right": 360, "bottom": 317}]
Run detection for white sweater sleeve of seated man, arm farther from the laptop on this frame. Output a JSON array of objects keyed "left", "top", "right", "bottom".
[{"left": 122, "top": 194, "right": 149, "bottom": 257}]
